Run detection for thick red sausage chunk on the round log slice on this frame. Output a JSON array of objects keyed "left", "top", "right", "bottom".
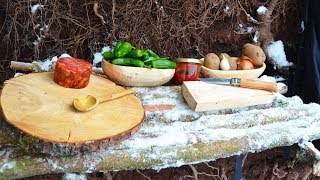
[{"left": 53, "top": 57, "right": 92, "bottom": 89}]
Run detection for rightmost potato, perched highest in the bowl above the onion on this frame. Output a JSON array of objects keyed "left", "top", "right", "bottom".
[{"left": 242, "top": 43, "right": 266, "bottom": 67}]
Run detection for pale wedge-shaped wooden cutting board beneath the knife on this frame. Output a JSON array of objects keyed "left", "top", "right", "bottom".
[{"left": 182, "top": 81, "right": 274, "bottom": 112}]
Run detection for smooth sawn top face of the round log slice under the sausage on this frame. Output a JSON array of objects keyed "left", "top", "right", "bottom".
[{"left": 1, "top": 72, "right": 145, "bottom": 144}]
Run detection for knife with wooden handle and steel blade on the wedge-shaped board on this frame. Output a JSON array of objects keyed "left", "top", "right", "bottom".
[{"left": 199, "top": 78, "right": 278, "bottom": 92}]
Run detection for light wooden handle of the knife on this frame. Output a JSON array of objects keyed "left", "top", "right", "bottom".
[{"left": 240, "top": 79, "right": 278, "bottom": 92}]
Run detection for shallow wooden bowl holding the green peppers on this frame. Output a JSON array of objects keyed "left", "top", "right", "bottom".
[{"left": 101, "top": 60, "right": 175, "bottom": 86}]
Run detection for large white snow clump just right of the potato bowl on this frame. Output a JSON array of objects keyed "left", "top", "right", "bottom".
[{"left": 267, "top": 40, "right": 293, "bottom": 67}]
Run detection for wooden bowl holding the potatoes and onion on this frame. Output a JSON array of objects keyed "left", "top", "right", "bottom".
[{"left": 200, "top": 63, "right": 266, "bottom": 79}]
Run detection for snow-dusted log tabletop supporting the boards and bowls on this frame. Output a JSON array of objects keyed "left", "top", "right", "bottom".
[{"left": 0, "top": 86, "right": 320, "bottom": 178}]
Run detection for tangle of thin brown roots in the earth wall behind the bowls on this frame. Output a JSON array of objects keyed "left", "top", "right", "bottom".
[{"left": 2, "top": 0, "right": 297, "bottom": 64}]
